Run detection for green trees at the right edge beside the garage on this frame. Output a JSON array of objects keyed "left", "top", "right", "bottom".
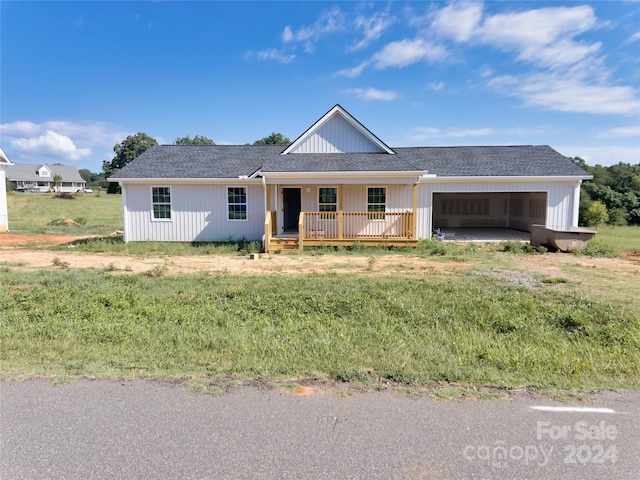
[{"left": 570, "top": 157, "right": 640, "bottom": 226}]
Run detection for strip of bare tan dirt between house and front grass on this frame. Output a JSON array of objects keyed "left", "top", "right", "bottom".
[{"left": 0, "top": 234, "right": 640, "bottom": 277}]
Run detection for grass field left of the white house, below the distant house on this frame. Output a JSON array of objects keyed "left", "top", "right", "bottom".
[{"left": 7, "top": 192, "right": 122, "bottom": 235}]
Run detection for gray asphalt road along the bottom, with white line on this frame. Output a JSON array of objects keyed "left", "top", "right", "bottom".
[{"left": 0, "top": 380, "right": 640, "bottom": 480}]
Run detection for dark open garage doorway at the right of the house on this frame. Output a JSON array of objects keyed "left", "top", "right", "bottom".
[{"left": 432, "top": 192, "right": 547, "bottom": 232}]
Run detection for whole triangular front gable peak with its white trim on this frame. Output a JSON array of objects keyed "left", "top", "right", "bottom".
[{"left": 282, "top": 103, "right": 395, "bottom": 155}]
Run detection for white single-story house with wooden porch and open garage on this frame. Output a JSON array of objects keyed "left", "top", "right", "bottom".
[{"left": 109, "top": 105, "right": 591, "bottom": 251}]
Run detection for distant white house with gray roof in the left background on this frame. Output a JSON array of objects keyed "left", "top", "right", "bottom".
[{"left": 7, "top": 163, "right": 86, "bottom": 193}]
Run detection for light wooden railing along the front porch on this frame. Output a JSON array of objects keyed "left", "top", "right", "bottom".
[{"left": 298, "top": 212, "right": 414, "bottom": 241}]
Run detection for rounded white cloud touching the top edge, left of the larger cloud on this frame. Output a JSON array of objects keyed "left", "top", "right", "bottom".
[{"left": 431, "top": 1, "right": 482, "bottom": 42}]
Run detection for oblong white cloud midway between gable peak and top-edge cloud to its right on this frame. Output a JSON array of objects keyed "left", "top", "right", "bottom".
[{"left": 372, "top": 38, "right": 447, "bottom": 70}]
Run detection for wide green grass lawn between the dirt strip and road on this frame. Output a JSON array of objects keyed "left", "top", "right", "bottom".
[{"left": 0, "top": 267, "right": 640, "bottom": 390}]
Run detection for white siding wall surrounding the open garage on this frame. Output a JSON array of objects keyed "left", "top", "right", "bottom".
[{"left": 417, "top": 179, "right": 579, "bottom": 238}]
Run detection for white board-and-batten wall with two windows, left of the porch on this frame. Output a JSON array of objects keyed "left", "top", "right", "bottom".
[{"left": 123, "top": 183, "right": 265, "bottom": 242}]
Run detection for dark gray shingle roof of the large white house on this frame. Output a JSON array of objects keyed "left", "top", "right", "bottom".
[{"left": 111, "top": 145, "right": 587, "bottom": 179}]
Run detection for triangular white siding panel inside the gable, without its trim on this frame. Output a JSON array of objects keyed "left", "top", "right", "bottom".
[{"left": 290, "top": 115, "right": 382, "bottom": 153}]
